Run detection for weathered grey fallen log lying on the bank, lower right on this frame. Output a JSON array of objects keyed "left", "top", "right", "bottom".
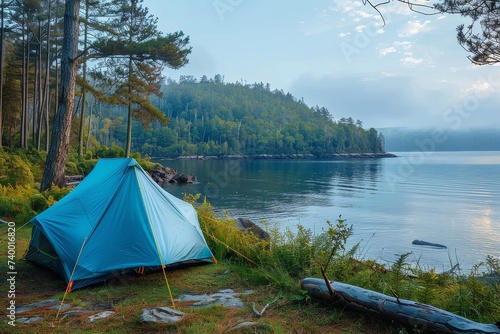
[{"left": 301, "top": 278, "right": 500, "bottom": 334}]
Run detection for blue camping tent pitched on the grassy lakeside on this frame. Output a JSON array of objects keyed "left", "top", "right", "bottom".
[{"left": 25, "top": 158, "right": 213, "bottom": 289}]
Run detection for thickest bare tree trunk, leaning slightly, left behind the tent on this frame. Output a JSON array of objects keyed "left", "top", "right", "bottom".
[{"left": 40, "top": 0, "right": 80, "bottom": 191}]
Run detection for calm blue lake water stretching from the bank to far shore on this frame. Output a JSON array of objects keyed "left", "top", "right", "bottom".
[{"left": 159, "top": 152, "right": 500, "bottom": 272}]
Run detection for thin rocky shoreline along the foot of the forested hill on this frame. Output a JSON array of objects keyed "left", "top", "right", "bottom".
[{"left": 152, "top": 153, "right": 397, "bottom": 160}]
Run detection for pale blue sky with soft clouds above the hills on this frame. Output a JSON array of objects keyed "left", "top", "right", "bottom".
[{"left": 143, "top": 0, "right": 500, "bottom": 130}]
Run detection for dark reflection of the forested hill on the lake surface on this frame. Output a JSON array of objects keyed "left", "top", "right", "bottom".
[{"left": 160, "top": 160, "right": 382, "bottom": 212}]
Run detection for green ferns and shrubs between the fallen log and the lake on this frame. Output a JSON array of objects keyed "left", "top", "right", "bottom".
[{"left": 190, "top": 196, "right": 500, "bottom": 323}]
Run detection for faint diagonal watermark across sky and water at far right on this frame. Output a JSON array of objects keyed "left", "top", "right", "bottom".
[{"left": 386, "top": 75, "right": 495, "bottom": 191}]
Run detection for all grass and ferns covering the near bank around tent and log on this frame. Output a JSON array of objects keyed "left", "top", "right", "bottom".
[{"left": 0, "top": 210, "right": 500, "bottom": 334}]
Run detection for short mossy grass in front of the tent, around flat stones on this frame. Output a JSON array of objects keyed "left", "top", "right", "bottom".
[{"left": 0, "top": 224, "right": 398, "bottom": 334}]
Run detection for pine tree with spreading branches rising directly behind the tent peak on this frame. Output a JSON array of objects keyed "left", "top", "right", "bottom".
[{"left": 92, "top": 0, "right": 191, "bottom": 156}]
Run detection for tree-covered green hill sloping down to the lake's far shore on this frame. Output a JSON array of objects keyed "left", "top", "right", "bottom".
[{"left": 94, "top": 75, "right": 384, "bottom": 157}]
